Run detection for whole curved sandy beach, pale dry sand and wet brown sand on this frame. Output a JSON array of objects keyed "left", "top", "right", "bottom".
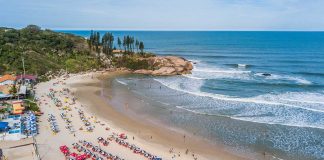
[{"left": 2, "top": 72, "right": 246, "bottom": 160}]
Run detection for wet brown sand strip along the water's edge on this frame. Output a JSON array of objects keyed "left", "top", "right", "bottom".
[{"left": 70, "top": 73, "right": 245, "bottom": 159}]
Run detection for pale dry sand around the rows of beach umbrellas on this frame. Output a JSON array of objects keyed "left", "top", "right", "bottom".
[{"left": 36, "top": 73, "right": 210, "bottom": 160}]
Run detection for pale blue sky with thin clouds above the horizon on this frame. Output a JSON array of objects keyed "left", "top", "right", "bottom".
[{"left": 0, "top": 0, "right": 324, "bottom": 31}]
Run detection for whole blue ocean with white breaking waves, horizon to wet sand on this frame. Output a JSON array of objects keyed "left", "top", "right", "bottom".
[{"left": 60, "top": 31, "right": 324, "bottom": 160}]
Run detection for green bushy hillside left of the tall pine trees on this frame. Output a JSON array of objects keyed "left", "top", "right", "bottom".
[{"left": 0, "top": 25, "right": 98, "bottom": 75}]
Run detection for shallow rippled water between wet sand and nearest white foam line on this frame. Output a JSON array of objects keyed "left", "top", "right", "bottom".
[{"left": 112, "top": 76, "right": 324, "bottom": 160}]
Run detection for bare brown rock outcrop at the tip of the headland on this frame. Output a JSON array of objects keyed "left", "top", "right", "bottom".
[{"left": 134, "top": 56, "right": 193, "bottom": 76}]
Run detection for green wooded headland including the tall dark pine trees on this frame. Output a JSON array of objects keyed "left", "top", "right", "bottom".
[{"left": 0, "top": 25, "right": 153, "bottom": 75}]
